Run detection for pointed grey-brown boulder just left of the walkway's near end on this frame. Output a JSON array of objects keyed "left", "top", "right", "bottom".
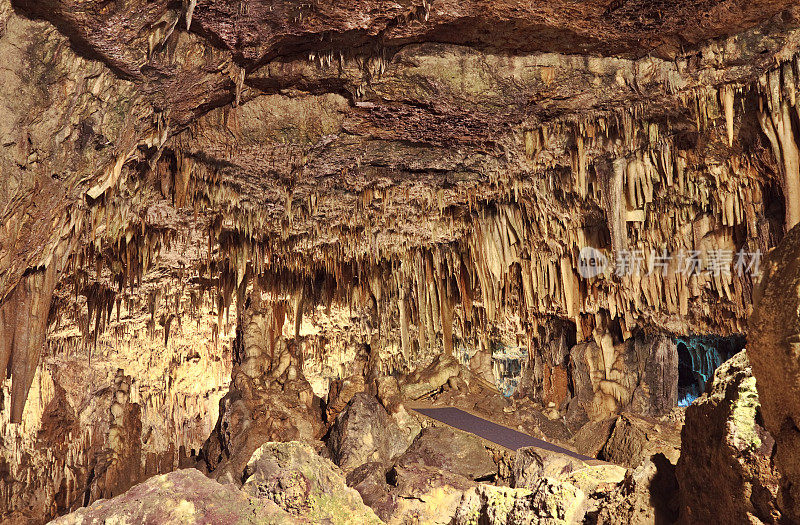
[{"left": 327, "top": 392, "right": 413, "bottom": 471}]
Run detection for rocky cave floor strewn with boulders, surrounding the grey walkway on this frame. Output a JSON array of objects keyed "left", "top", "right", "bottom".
[{"left": 39, "top": 341, "right": 781, "bottom": 524}]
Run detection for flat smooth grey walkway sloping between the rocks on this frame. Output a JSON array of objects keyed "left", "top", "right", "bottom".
[{"left": 414, "top": 407, "right": 597, "bottom": 462}]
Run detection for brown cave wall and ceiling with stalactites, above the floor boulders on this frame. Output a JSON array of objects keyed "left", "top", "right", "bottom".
[{"left": 0, "top": 0, "right": 800, "bottom": 519}]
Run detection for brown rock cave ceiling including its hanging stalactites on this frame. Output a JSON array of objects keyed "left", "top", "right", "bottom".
[{"left": 0, "top": 0, "right": 800, "bottom": 434}]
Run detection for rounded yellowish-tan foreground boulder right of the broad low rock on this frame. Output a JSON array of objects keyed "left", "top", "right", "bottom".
[{"left": 242, "top": 442, "right": 380, "bottom": 524}]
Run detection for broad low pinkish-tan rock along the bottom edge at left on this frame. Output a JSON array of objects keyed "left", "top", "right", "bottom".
[{"left": 53, "top": 469, "right": 298, "bottom": 525}]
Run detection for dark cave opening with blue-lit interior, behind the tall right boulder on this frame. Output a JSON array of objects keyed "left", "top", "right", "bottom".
[{"left": 676, "top": 335, "right": 745, "bottom": 407}]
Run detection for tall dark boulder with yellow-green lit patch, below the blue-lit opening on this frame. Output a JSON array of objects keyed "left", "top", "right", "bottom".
[{"left": 677, "top": 351, "right": 781, "bottom": 523}]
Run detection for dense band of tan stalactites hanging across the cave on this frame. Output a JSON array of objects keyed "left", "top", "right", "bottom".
[{"left": 15, "top": 36, "right": 800, "bottom": 424}]
